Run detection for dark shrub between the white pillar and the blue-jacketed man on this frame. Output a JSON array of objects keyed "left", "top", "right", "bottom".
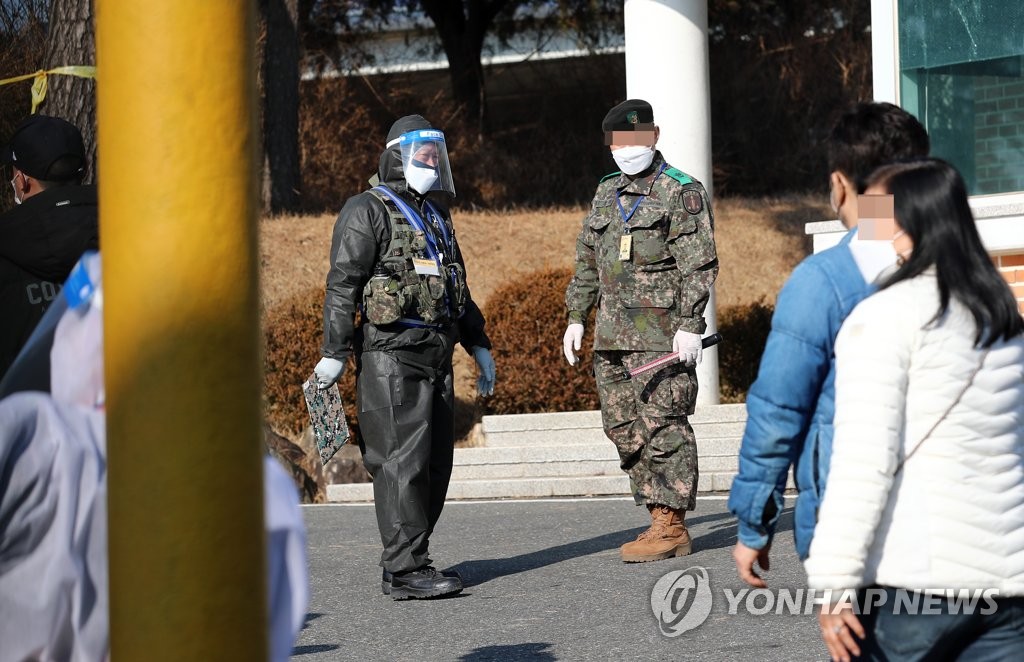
[{"left": 718, "top": 298, "right": 774, "bottom": 403}]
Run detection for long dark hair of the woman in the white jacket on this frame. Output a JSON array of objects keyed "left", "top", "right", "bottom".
[{"left": 867, "top": 159, "right": 1024, "bottom": 347}]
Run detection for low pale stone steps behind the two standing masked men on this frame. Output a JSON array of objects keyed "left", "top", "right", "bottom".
[{"left": 327, "top": 405, "right": 746, "bottom": 502}]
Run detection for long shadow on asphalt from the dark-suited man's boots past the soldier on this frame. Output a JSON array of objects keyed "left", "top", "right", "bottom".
[{"left": 450, "top": 512, "right": 745, "bottom": 586}]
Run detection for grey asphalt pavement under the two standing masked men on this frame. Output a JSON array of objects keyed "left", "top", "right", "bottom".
[{"left": 292, "top": 497, "right": 827, "bottom": 662}]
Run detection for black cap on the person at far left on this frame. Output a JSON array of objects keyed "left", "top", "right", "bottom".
[{"left": 0, "top": 115, "right": 85, "bottom": 181}]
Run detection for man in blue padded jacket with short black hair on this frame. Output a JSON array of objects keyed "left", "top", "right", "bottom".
[{"left": 729, "top": 102, "right": 929, "bottom": 587}]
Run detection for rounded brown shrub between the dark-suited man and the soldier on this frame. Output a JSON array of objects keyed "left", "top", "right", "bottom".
[{"left": 484, "top": 268, "right": 598, "bottom": 414}]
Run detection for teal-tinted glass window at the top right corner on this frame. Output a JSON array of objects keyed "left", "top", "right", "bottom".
[{"left": 898, "top": 0, "right": 1024, "bottom": 195}]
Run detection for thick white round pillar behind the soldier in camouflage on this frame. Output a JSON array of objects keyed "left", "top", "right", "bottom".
[{"left": 625, "top": 0, "right": 720, "bottom": 405}]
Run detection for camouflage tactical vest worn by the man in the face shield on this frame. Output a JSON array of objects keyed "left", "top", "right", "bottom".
[{"left": 362, "top": 187, "right": 467, "bottom": 330}]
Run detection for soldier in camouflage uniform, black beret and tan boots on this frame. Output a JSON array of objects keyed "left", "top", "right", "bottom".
[{"left": 563, "top": 99, "right": 718, "bottom": 563}]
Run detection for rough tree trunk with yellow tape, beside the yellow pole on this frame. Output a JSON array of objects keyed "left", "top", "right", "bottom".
[{"left": 41, "top": 0, "right": 96, "bottom": 182}]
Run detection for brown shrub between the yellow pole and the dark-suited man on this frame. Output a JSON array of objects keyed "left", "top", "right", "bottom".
[{"left": 263, "top": 288, "right": 358, "bottom": 440}]
